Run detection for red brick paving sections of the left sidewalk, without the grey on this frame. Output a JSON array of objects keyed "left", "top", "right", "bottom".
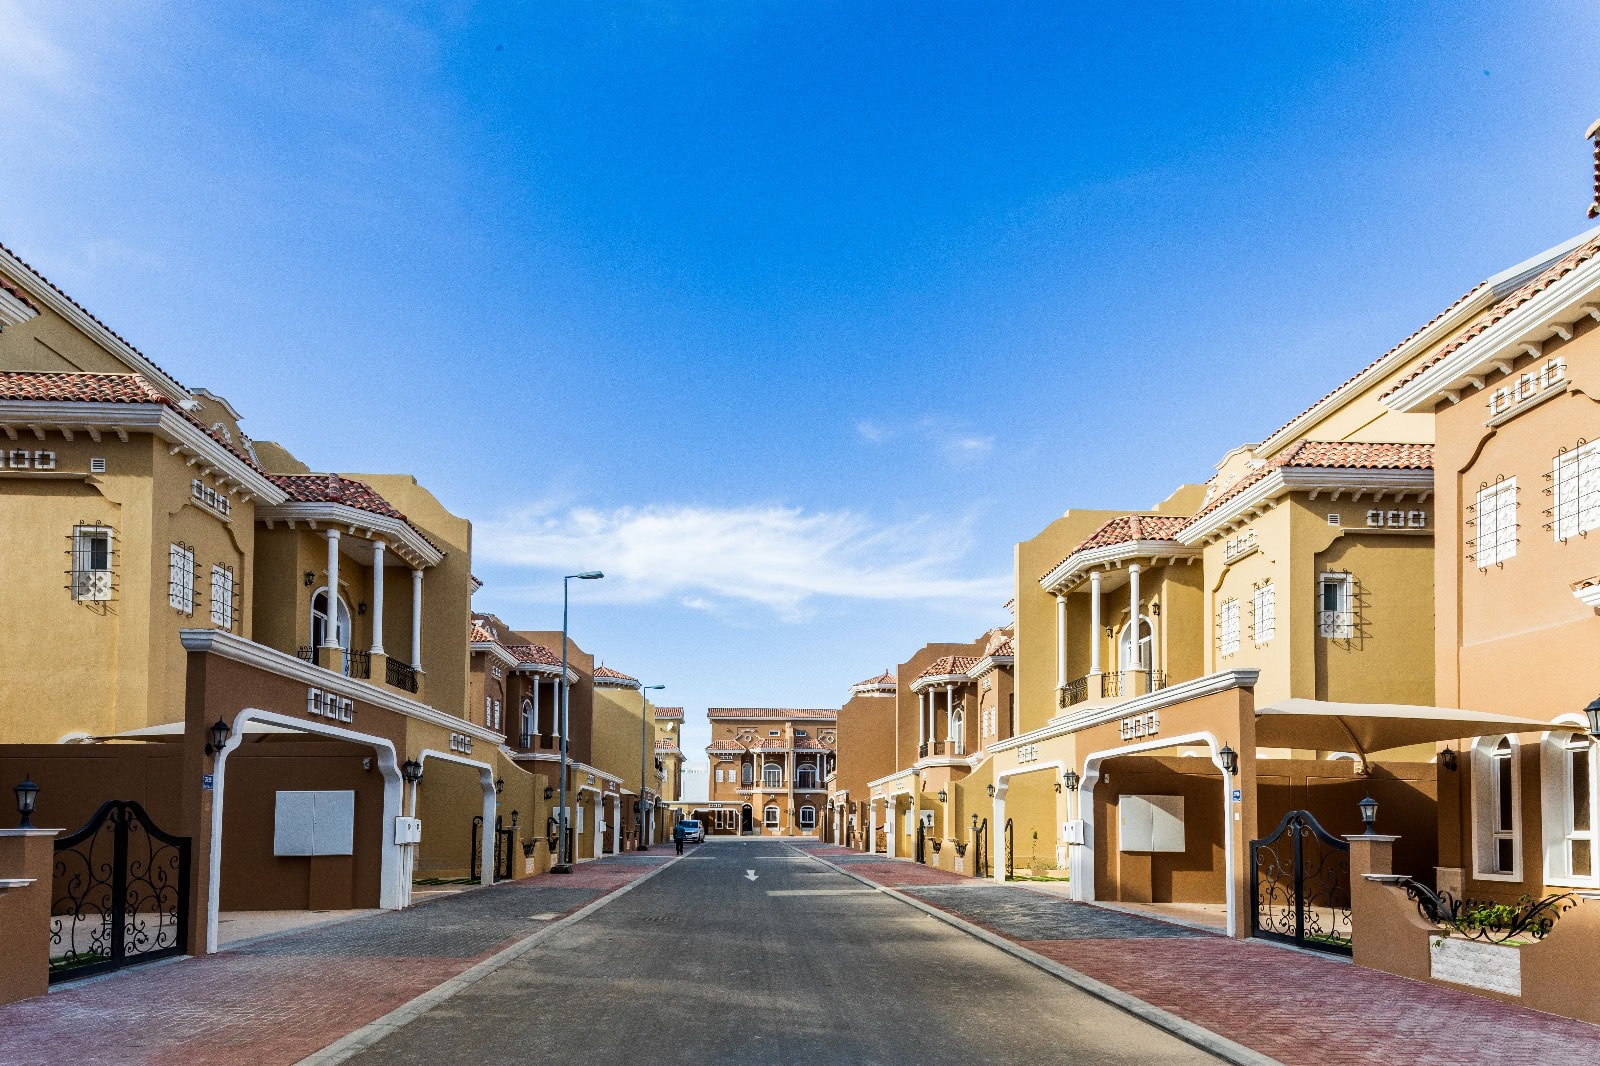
[{"left": 0, "top": 853, "right": 670, "bottom": 1066}]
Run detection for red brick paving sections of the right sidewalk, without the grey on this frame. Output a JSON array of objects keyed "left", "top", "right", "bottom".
[{"left": 825, "top": 847, "right": 1600, "bottom": 1066}]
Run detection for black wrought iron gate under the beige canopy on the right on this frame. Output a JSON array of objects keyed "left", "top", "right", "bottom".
[{"left": 1250, "top": 810, "right": 1350, "bottom": 956}]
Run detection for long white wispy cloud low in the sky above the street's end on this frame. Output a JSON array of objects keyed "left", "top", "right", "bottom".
[{"left": 475, "top": 504, "right": 1010, "bottom": 621}]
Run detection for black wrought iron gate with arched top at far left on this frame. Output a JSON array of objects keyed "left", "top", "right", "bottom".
[{"left": 50, "top": 800, "right": 189, "bottom": 983}]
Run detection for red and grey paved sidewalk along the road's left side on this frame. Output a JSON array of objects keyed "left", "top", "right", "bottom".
[{"left": 0, "top": 848, "right": 672, "bottom": 1066}]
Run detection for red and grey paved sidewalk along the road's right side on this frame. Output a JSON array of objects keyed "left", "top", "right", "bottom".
[{"left": 792, "top": 845, "right": 1600, "bottom": 1066}]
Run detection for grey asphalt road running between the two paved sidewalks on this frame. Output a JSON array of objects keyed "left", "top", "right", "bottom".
[{"left": 354, "top": 840, "right": 1216, "bottom": 1066}]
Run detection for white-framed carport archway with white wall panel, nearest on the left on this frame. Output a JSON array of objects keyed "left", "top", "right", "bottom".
[{"left": 206, "top": 707, "right": 408, "bottom": 951}]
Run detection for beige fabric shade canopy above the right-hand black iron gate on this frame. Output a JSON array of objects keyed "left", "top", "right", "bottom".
[{"left": 1256, "top": 699, "right": 1584, "bottom": 759}]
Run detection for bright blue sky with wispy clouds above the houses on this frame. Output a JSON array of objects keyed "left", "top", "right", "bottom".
[{"left": 0, "top": 0, "right": 1600, "bottom": 787}]
